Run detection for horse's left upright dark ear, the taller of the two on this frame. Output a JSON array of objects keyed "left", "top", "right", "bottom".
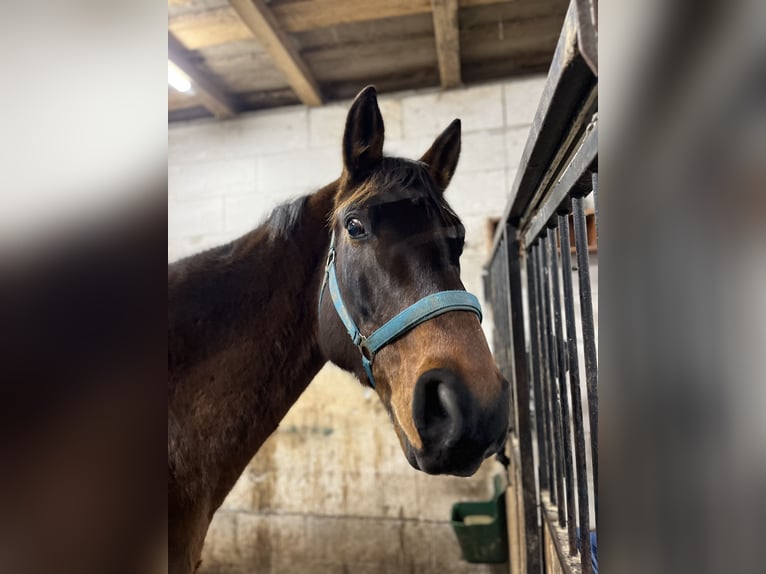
[{"left": 343, "top": 86, "right": 384, "bottom": 179}]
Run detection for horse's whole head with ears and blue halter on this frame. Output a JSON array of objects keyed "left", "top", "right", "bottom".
[{"left": 319, "top": 87, "right": 509, "bottom": 476}]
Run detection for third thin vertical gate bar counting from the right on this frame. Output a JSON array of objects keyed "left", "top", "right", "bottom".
[{"left": 547, "top": 228, "right": 577, "bottom": 556}]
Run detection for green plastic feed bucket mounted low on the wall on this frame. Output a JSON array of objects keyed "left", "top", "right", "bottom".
[{"left": 452, "top": 475, "right": 508, "bottom": 564}]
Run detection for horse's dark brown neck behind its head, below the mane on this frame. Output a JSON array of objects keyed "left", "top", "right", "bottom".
[{"left": 168, "top": 184, "right": 335, "bottom": 506}]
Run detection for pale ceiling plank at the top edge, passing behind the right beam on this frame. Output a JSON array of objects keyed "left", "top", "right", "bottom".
[{"left": 272, "top": 0, "right": 510, "bottom": 32}]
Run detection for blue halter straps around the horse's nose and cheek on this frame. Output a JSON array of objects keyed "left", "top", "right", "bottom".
[{"left": 319, "top": 231, "right": 482, "bottom": 388}]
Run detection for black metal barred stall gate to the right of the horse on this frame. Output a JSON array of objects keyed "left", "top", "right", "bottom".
[{"left": 484, "top": 0, "right": 598, "bottom": 574}]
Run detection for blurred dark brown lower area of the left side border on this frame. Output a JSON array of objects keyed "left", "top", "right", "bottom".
[{"left": 0, "top": 186, "right": 167, "bottom": 573}]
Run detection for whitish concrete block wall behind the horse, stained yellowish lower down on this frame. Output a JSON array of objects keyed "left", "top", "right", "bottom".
[{"left": 168, "top": 76, "right": 545, "bottom": 574}]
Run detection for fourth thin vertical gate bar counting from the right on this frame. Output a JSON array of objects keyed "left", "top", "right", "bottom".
[{"left": 540, "top": 235, "right": 566, "bottom": 528}]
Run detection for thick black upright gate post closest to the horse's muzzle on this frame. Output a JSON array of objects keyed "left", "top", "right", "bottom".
[{"left": 506, "top": 224, "right": 542, "bottom": 574}]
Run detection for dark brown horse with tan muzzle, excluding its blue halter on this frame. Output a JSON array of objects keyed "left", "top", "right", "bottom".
[{"left": 168, "top": 87, "right": 509, "bottom": 573}]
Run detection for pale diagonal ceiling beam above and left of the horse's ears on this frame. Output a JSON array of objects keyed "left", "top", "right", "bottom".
[{"left": 229, "top": 0, "right": 322, "bottom": 106}]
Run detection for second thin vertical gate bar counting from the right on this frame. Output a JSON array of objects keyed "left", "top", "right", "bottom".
[{"left": 572, "top": 197, "right": 598, "bottom": 527}]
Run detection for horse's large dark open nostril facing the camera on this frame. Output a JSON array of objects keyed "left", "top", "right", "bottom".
[{"left": 412, "top": 369, "right": 464, "bottom": 446}]
